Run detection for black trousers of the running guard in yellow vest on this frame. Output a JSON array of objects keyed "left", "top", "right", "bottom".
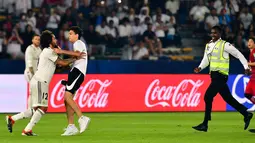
[{"left": 204, "top": 71, "right": 248, "bottom": 124}]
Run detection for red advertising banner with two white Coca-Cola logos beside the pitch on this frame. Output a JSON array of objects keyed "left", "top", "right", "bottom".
[{"left": 45, "top": 74, "right": 226, "bottom": 112}]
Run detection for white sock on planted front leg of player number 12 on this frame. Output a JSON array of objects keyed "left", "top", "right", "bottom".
[{"left": 25, "top": 108, "right": 45, "bottom": 131}]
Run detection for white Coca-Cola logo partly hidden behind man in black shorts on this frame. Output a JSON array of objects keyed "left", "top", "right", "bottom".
[{"left": 50, "top": 79, "right": 112, "bottom": 108}]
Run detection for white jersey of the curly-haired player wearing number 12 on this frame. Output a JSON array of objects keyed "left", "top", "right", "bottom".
[{"left": 33, "top": 47, "right": 58, "bottom": 84}]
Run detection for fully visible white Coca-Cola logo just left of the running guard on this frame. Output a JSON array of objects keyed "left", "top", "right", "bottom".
[{"left": 145, "top": 79, "right": 204, "bottom": 107}]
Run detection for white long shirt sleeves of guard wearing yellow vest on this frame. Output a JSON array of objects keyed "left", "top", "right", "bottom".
[{"left": 198, "top": 38, "right": 249, "bottom": 70}]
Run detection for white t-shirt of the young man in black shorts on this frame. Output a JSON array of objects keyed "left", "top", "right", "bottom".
[{"left": 73, "top": 40, "right": 88, "bottom": 75}]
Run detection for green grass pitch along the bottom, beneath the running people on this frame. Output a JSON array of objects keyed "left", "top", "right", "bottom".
[{"left": 0, "top": 112, "right": 255, "bottom": 143}]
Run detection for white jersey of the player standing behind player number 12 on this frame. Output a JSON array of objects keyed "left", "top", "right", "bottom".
[{"left": 25, "top": 44, "right": 42, "bottom": 72}]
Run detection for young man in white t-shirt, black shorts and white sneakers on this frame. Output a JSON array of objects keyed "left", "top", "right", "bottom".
[{"left": 53, "top": 26, "right": 90, "bottom": 136}]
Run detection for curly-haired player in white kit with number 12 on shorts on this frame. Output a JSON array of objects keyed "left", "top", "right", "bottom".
[{"left": 6, "top": 31, "right": 81, "bottom": 136}]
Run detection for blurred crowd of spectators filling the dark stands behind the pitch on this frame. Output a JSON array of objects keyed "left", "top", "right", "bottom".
[{"left": 0, "top": 0, "right": 255, "bottom": 60}]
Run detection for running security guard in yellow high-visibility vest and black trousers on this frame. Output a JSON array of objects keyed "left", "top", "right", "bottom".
[{"left": 192, "top": 26, "right": 253, "bottom": 132}]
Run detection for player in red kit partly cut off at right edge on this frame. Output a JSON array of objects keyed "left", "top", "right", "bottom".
[{"left": 245, "top": 38, "right": 255, "bottom": 104}]
